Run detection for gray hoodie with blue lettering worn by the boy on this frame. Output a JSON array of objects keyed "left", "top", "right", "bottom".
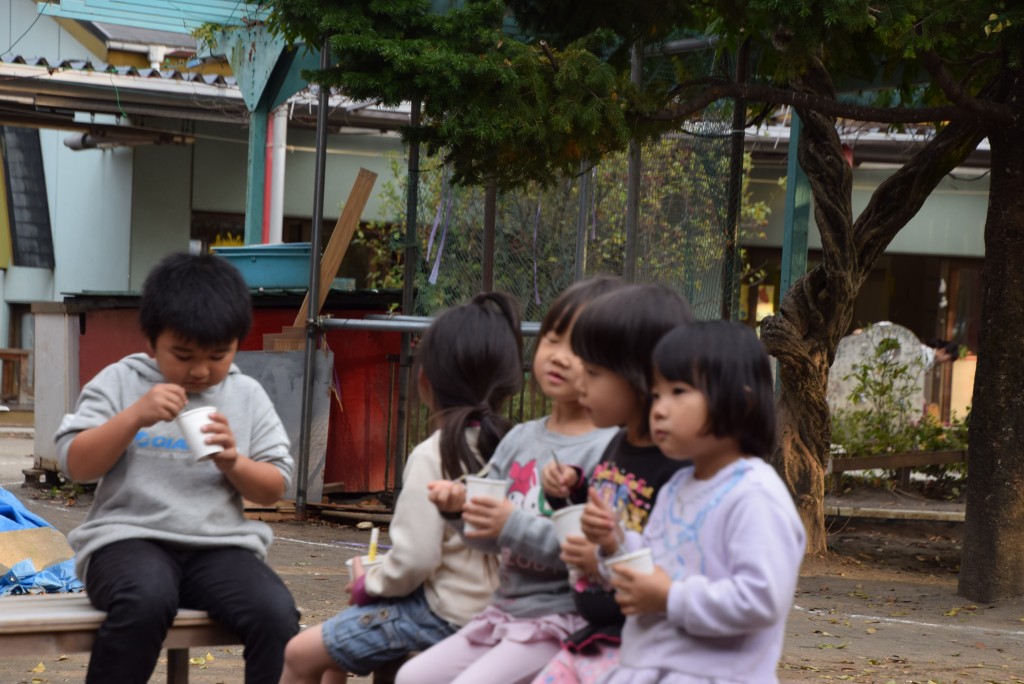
[{"left": 54, "top": 354, "right": 292, "bottom": 580}]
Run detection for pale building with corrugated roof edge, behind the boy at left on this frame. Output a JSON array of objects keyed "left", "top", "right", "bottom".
[{"left": 0, "top": 0, "right": 404, "bottom": 411}]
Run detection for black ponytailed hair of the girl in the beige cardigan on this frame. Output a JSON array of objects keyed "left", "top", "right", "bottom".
[{"left": 416, "top": 292, "right": 522, "bottom": 479}]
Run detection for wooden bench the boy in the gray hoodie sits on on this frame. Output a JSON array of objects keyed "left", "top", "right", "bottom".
[{"left": 0, "top": 593, "right": 241, "bottom": 684}]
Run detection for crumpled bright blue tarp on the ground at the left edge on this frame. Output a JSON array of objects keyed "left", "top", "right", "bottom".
[{"left": 0, "top": 487, "right": 83, "bottom": 596}]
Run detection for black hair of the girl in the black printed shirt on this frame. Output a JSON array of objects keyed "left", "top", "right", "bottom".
[{"left": 572, "top": 285, "right": 693, "bottom": 436}]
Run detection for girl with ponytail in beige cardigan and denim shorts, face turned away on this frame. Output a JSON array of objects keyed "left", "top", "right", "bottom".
[{"left": 281, "top": 292, "right": 522, "bottom": 684}]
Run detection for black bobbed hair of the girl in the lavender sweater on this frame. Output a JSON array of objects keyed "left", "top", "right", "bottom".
[{"left": 652, "top": 320, "right": 775, "bottom": 458}]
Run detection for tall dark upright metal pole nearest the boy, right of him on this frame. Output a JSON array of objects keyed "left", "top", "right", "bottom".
[{"left": 295, "top": 36, "right": 331, "bottom": 520}]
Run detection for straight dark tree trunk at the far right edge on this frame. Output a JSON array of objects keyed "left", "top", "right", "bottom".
[{"left": 958, "top": 71, "right": 1024, "bottom": 602}]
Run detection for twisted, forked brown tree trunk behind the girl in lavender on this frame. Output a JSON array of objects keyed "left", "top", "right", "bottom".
[{"left": 761, "top": 58, "right": 984, "bottom": 554}]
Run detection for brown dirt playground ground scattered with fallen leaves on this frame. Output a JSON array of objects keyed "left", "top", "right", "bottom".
[{"left": 0, "top": 475, "right": 1024, "bottom": 684}]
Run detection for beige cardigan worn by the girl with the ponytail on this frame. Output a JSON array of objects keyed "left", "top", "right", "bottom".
[{"left": 366, "top": 428, "right": 498, "bottom": 626}]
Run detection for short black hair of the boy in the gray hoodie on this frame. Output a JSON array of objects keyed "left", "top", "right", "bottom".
[{"left": 138, "top": 253, "right": 253, "bottom": 347}]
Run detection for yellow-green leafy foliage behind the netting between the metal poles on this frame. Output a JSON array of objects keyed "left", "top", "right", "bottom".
[{"left": 356, "top": 123, "right": 769, "bottom": 320}]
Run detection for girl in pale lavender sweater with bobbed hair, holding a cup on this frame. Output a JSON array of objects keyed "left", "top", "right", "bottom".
[{"left": 582, "top": 320, "right": 805, "bottom": 684}]
